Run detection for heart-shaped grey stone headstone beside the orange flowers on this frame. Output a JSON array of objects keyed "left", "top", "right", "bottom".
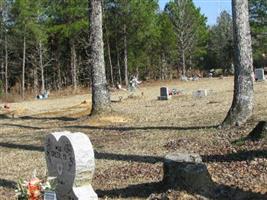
[{"left": 45, "top": 131, "right": 98, "bottom": 200}]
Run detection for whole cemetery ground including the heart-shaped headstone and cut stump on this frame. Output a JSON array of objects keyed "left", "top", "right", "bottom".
[{"left": 0, "top": 77, "right": 267, "bottom": 199}]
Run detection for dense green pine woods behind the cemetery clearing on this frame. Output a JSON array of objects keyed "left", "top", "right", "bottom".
[{"left": 0, "top": 0, "right": 267, "bottom": 97}]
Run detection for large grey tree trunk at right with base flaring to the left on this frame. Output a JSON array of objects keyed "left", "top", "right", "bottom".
[{"left": 222, "top": 0, "right": 253, "bottom": 128}]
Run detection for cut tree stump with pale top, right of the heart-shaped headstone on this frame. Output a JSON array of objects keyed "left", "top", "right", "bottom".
[{"left": 163, "top": 152, "right": 215, "bottom": 196}]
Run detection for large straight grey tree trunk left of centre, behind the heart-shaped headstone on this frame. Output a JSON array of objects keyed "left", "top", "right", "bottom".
[{"left": 88, "top": 0, "right": 111, "bottom": 115}]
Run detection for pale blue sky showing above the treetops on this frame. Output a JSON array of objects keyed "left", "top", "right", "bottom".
[{"left": 159, "top": 0, "right": 232, "bottom": 25}]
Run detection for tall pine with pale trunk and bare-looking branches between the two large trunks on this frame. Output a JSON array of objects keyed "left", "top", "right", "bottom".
[{"left": 165, "top": 0, "right": 206, "bottom": 75}]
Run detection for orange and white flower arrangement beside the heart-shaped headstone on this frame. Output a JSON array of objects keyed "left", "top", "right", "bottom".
[{"left": 15, "top": 175, "right": 56, "bottom": 200}]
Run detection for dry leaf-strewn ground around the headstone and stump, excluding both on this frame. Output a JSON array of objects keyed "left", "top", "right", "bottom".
[{"left": 0, "top": 78, "right": 267, "bottom": 199}]
